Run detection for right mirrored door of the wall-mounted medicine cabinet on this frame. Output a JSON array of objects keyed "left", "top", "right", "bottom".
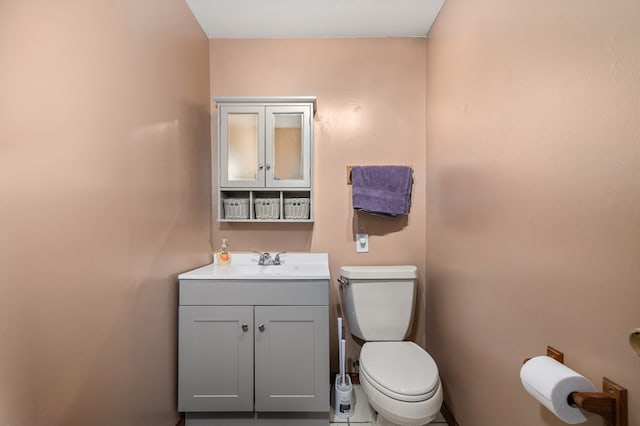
[{"left": 265, "top": 105, "right": 311, "bottom": 188}]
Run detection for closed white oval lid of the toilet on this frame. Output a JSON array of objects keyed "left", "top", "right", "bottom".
[{"left": 360, "top": 342, "right": 440, "bottom": 402}]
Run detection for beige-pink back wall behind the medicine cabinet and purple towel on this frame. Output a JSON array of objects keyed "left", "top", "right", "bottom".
[{"left": 210, "top": 39, "right": 426, "bottom": 370}]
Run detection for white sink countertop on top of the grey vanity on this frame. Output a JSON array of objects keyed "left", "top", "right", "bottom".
[{"left": 178, "top": 252, "right": 329, "bottom": 280}]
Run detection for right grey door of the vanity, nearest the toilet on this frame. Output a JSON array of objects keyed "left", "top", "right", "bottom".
[{"left": 255, "top": 306, "right": 330, "bottom": 411}]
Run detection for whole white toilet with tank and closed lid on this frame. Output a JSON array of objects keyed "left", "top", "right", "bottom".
[{"left": 339, "top": 266, "right": 442, "bottom": 426}]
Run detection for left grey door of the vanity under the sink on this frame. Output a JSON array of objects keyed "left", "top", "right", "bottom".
[{"left": 178, "top": 306, "right": 254, "bottom": 412}]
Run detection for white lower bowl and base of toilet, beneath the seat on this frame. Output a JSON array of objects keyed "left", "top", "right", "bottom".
[{"left": 360, "top": 374, "right": 443, "bottom": 426}]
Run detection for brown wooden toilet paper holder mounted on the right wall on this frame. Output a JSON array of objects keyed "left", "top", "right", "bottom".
[{"left": 524, "top": 346, "right": 629, "bottom": 426}]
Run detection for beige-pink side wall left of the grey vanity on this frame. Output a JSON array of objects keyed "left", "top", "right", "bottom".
[{"left": 0, "top": 0, "right": 211, "bottom": 426}]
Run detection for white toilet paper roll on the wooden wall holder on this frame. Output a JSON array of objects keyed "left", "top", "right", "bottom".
[{"left": 520, "top": 356, "right": 596, "bottom": 424}]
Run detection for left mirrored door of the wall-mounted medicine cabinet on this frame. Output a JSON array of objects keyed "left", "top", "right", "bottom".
[{"left": 220, "top": 106, "right": 266, "bottom": 187}]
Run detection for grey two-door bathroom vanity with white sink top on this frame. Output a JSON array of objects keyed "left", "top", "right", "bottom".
[{"left": 178, "top": 253, "right": 330, "bottom": 426}]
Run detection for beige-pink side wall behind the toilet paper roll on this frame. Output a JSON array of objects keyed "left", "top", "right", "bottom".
[{"left": 426, "top": 0, "right": 640, "bottom": 426}]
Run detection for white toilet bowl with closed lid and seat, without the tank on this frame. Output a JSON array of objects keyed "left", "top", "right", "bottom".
[{"left": 360, "top": 342, "right": 443, "bottom": 426}]
